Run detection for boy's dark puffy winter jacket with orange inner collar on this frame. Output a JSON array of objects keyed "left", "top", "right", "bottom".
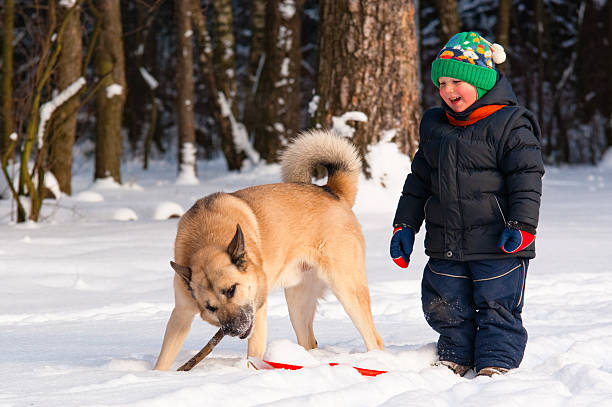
[{"left": 393, "top": 73, "right": 544, "bottom": 260}]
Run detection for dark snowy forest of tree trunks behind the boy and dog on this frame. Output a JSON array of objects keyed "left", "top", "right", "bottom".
[{"left": 0, "top": 0, "right": 612, "bottom": 222}]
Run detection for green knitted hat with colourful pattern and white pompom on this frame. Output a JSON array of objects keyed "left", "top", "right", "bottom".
[{"left": 431, "top": 31, "right": 506, "bottom": 99}]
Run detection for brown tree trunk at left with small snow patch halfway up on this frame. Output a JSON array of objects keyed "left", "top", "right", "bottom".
[{"left": 94, "top": 0, "right": 127, "bottom": 182}]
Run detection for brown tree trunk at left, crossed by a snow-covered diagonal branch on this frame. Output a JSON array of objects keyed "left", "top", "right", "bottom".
[{"left": 48, "top": 0, "right": 83, "bottom": 195}]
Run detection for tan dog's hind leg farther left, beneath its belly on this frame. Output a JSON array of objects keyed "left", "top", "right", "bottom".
[{"left": 285, "top": 270, "right": 325, "bottom": 350}]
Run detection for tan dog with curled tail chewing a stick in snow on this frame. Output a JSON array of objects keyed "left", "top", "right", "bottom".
[{"left": 155, "top": 130, "right": 384, "bottom": 370}]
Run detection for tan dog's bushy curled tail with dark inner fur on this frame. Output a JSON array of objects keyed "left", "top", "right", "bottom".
[{"left": 281, "top": 130, "right": 361, "bottom": 206}]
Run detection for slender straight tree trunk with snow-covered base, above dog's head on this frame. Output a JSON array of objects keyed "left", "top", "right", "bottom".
[{"left": 174, "top": 0, "right": 197, "bottom": 183}]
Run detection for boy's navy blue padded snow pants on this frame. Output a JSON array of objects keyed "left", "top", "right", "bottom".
[{"left": 421, "top": 257, "right": 529, "bottom": 371}]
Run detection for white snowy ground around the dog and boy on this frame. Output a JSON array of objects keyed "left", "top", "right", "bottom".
[{"left": 0, "top": 145, "right": 612, "bottom": 407}]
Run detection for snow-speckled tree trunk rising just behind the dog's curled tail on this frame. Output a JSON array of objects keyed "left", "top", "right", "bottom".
[{"left": 253, "top": 0, "right": 302, "bottom": 162}]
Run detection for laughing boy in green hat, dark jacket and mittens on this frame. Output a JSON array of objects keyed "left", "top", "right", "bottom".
[{"left": 390, "top": 32, "right": 544, "bottom": 376}]
